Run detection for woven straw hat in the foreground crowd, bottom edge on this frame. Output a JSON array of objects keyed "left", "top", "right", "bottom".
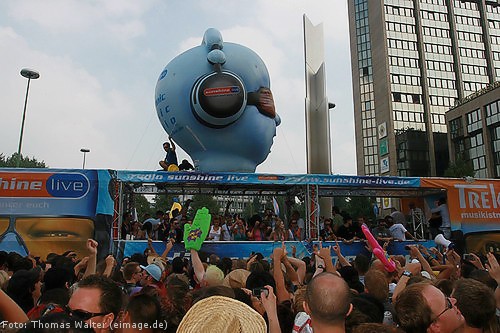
[{"left": 177, "top": 296, "right": 267, "bottom": 333}]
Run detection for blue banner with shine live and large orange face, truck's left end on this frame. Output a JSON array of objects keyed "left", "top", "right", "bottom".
[{"left": 0, "top": 168, "right": 114, "bottom": 258}]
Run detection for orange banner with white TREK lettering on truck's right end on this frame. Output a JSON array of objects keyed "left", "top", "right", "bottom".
[{"left": 421, "top": 178, "right": 500, "bottom": 234}]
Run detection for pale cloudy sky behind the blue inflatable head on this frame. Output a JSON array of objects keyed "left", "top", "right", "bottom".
[{"left": 0, "top": 0, "right": 356, "bottom": 174}]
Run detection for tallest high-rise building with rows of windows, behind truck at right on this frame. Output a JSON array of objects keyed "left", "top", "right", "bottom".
[{"left": 348, "top": 0, "right": 500, "bottom": 176}]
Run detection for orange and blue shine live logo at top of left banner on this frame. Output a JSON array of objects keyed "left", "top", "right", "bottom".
[{"left": 0, "top": 172, "right": 90, "bottom": 199}]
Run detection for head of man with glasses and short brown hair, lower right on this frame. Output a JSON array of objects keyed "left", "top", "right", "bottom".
[{"left": 394, "top": 283, "right": 465, "bottom": 333}]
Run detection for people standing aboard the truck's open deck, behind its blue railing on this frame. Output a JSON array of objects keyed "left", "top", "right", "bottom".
[{"left": 121, "top": 200, "right": 426, "bottom": 245}]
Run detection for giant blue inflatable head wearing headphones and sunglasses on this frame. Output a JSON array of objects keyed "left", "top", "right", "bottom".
[{"left": 155, "top": 28, "right": 280, "bottom": 172}]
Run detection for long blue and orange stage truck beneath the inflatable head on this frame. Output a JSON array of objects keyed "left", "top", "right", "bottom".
[{"left": 0, "top": 168, "right": 500, "bottom": 258}]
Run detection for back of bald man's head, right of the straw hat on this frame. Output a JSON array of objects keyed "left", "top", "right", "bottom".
[{"left": 304, "top": 273, "right": 352, "bottom": 333}]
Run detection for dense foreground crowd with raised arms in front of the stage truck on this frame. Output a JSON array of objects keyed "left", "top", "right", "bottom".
[{"left": 0, "top": 202, "right": 500, "bottom": 333}]
